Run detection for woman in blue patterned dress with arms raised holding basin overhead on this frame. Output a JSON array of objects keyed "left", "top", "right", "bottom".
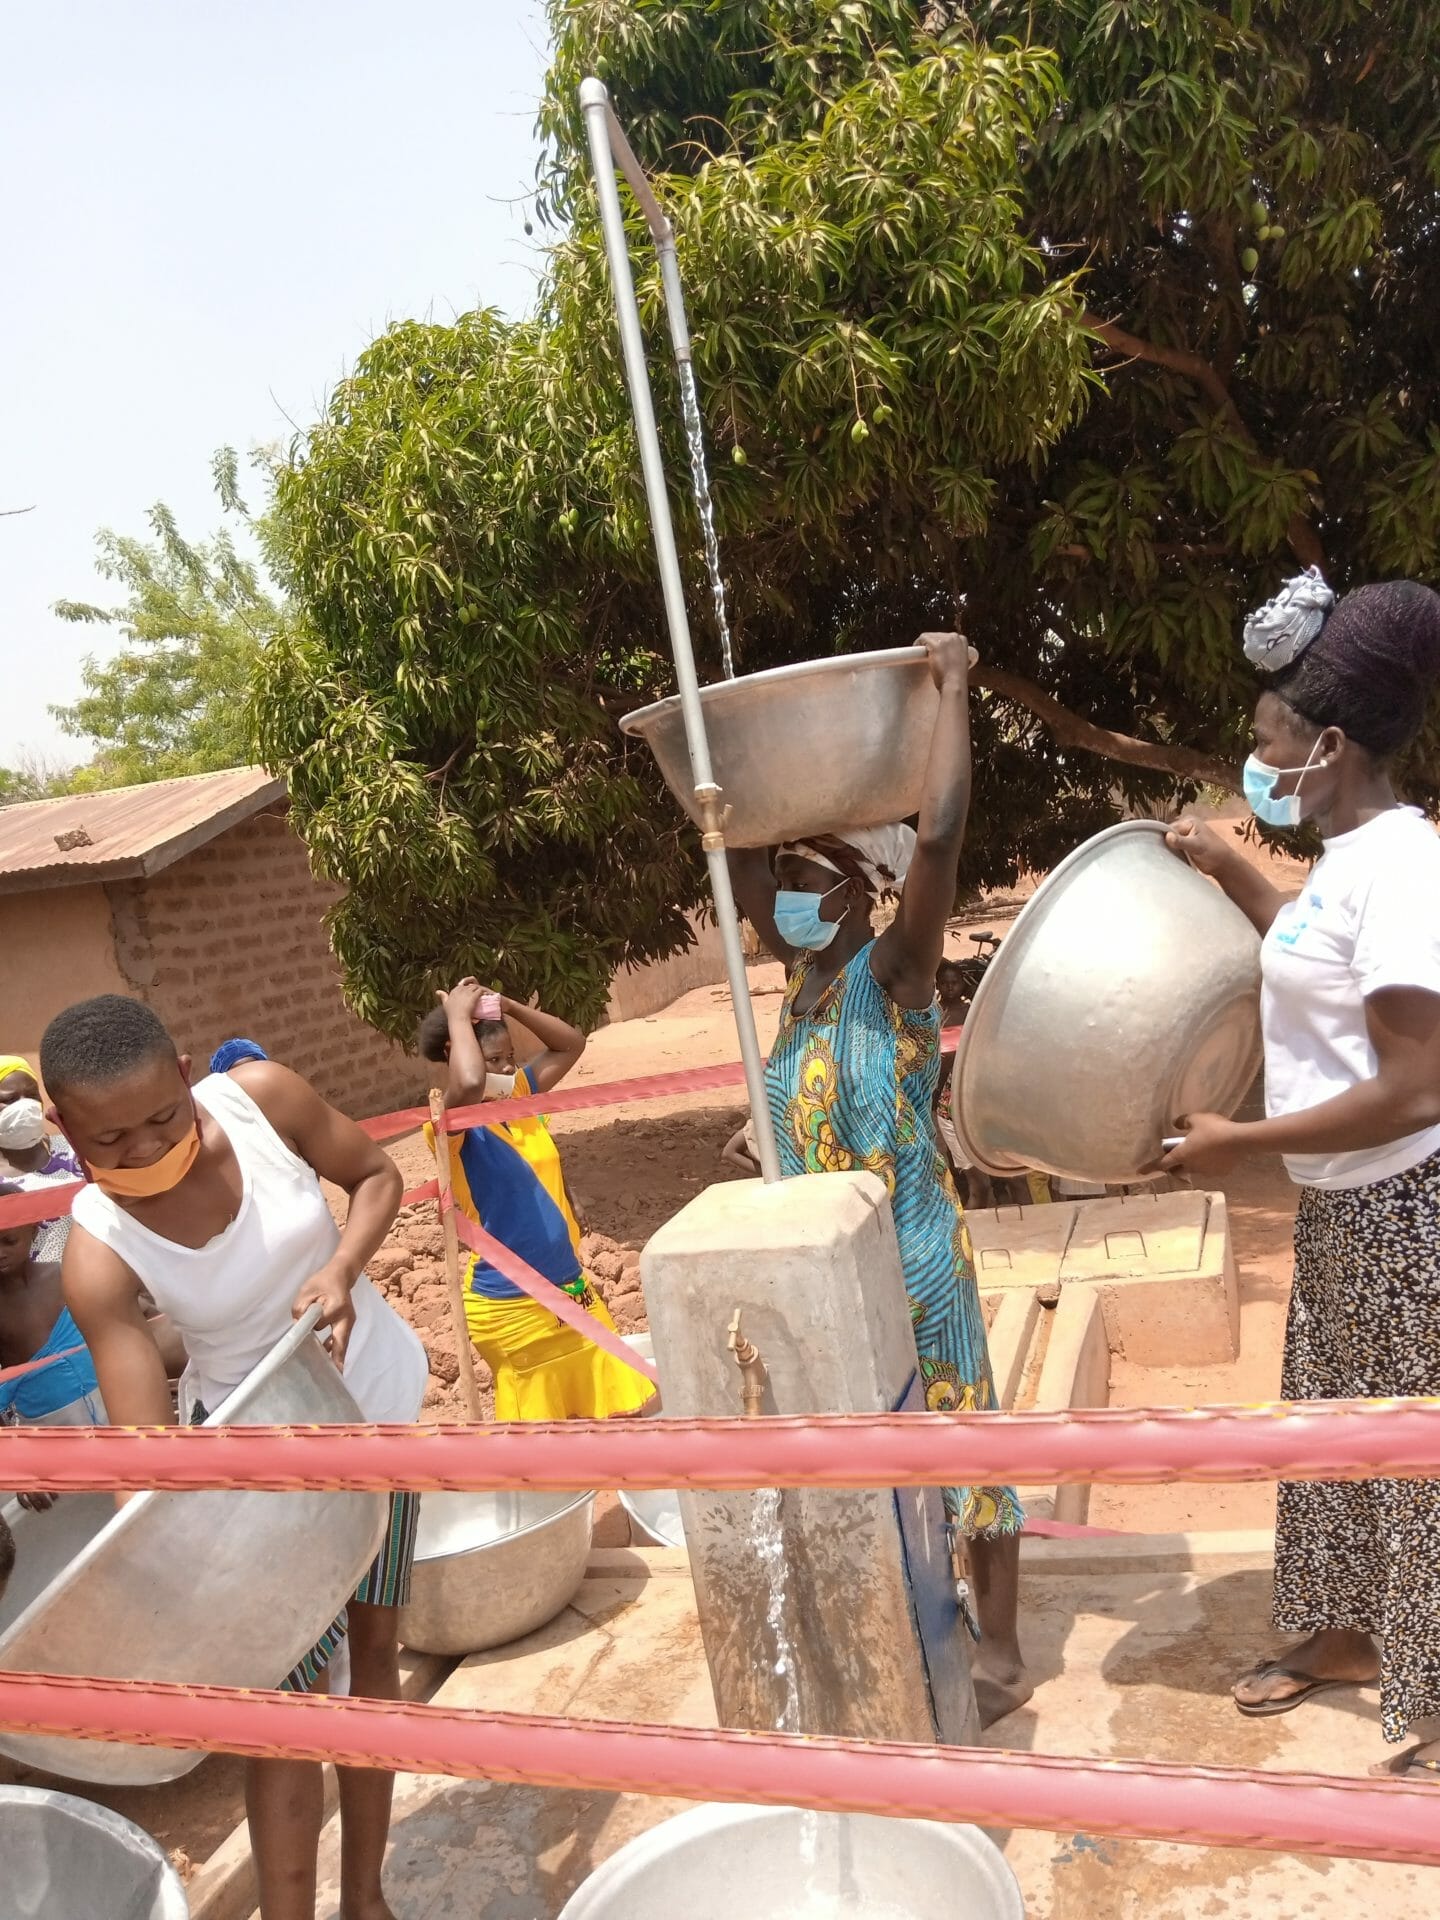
[{"left": 730, "top": 634, "right": 1031, "bottom": 1724}]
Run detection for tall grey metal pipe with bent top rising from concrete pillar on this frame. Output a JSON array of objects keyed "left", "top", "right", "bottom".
[{"left": 580, "top": 79, "right": 780, "bottom": 1181}]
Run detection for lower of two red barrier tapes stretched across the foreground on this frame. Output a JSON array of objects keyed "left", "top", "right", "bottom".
[{"left": 0, "top": 1674, "right": 1440, "bottom": 1866}]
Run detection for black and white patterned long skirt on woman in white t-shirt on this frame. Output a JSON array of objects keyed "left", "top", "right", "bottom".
[{"left": 1275, "top": 1154, "right": 1440, "bottom": 1741}]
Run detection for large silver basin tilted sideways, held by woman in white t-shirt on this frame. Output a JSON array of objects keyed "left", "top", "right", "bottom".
[{"left": 952, "top": 820, "right": 1260, "bottom": 1187}]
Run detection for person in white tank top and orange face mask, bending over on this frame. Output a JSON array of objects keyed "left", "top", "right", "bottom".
[{"left": 40, "top": 995, "right": 428, "bottom": 1920}]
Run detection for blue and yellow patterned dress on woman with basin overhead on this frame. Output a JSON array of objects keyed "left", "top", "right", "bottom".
[{"left": 766, "top": 941, "right": 1025, "bottom": 1534}]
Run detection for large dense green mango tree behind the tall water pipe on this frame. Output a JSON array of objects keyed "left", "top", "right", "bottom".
[{"left": 257, "top": 0, "right": 1440, "bottom": 1033}]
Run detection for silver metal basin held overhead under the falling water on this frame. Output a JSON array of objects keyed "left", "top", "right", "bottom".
[{"left": 620, "top": 647, "right": 939, "bottom": 847}]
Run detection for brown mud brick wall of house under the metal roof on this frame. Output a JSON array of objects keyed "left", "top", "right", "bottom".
[{"left": 106, "top": 810, "right": 426, "bottom": 1119}]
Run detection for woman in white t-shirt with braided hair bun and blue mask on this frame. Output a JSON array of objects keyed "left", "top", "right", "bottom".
[{"left": 1164, "top": 570, "right": 1440, "bottom": 1786}]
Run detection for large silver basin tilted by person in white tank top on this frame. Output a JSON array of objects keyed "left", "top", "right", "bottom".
[{"left": 0, "top": 1317, "right": 386, "bottom": 1781}]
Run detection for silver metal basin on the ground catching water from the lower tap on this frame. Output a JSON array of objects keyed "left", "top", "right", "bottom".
[{"left": 559, "top": 1805, "right": 1025, "bottom": 1920}]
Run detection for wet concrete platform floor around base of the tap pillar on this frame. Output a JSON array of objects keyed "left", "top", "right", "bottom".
[{"left": 272, "top": 1534, "right": 1440, "bottom": 1920}]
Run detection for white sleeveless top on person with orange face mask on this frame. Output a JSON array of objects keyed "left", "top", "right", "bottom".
[{"left": 73, "top": 1073, "right": 430, "bottom": 1421}]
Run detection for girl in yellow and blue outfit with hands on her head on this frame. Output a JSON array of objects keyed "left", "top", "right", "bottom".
[{"left": 419, "top": 979, "right": 655, "bottom": 1421}]
